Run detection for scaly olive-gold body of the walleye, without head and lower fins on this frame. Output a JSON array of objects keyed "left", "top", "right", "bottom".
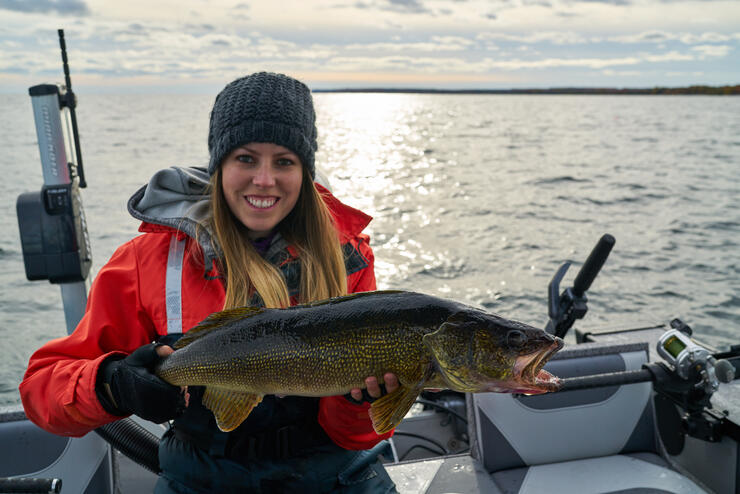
[{"left": 159, "top": 296, "right": 456, "bottom": 396}]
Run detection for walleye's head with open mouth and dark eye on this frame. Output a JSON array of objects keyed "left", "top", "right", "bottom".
[{"left": 424, "top": 309, "right": 563, "bottom": 394}]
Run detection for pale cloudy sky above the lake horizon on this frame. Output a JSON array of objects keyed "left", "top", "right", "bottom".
[{"left": 0, "top": 0, "right": 740, "bottom": 93}]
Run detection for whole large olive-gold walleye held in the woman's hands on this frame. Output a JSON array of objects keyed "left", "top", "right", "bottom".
[{"left": 156, "top": 291, "right": 563, "bottom": 434}]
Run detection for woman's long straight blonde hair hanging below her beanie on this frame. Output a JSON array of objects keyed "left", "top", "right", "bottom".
[{"left": 209, "top": 167, "right": 347, "bottom": 309}]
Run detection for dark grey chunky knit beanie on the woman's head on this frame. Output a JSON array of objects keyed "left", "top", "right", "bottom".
[{"left": 208, "top": 72, "right": 318, "bottom": 178}]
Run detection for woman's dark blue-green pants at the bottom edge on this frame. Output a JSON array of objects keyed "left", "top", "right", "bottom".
[{"left": 154, "top": 431, "right": 397, "bottom": 494}]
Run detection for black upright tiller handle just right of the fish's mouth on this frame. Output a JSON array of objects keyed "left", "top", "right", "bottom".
[{"left": 545, "top": 233, "right": 616, "bottom": 338}]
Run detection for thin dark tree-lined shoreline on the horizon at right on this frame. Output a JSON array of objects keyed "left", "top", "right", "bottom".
[{"left": 313, "top": 84, "right": 740, "bottom": 96}]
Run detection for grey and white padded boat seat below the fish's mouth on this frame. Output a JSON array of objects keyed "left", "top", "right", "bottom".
[{"left": 468, "top": 343, "right": 705, "bottom": 494}]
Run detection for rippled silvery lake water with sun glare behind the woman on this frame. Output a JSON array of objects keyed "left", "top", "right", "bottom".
[{"left": 0, "top": 94, "right": 740, "bottom": 405}]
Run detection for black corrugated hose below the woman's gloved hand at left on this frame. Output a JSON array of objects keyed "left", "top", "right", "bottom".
[{"left": 95, "top": 418, "right": 162, "bottom": 475}]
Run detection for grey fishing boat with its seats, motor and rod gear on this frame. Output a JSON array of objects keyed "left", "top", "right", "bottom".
[{"left": 0, "top": 30, "right": 740, "bottom": 494}]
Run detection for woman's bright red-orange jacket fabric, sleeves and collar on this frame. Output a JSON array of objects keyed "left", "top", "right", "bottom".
[{"left": 20, "top": 186, "right": 392, "bottom": 450}]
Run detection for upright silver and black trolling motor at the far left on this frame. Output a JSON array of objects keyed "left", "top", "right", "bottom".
[{"left": 16, "top": 29, "right": 92, "bottom": 333}]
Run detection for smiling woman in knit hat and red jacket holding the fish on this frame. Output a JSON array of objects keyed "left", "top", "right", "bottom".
[{"left": 20, "top": 73, "right": 398, "bottom": 493}]
